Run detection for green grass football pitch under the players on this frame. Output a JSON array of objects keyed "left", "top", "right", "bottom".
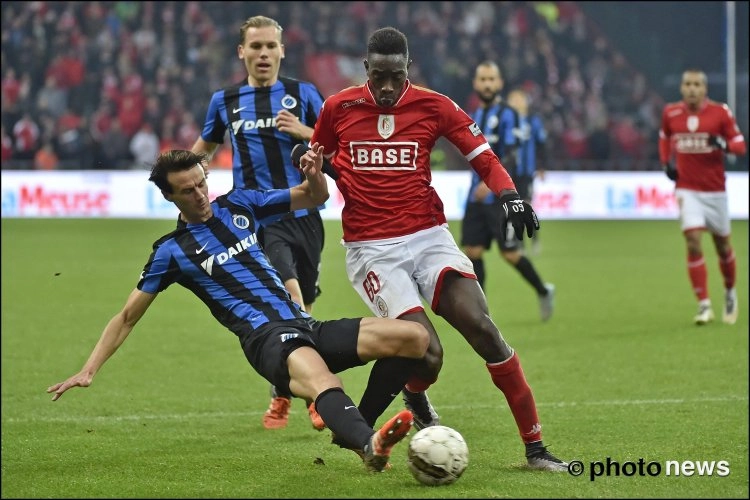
[{"left": 2, "top": 219, "right": 750, "bottom": 498}]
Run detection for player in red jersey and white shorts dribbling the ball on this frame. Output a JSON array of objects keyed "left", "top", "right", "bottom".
[{"left": 311, "top": 27, "right": 567, "bottom": 471}]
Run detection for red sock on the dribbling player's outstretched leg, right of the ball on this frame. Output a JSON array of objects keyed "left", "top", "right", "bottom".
[{"left": 487, "top": 352, "right": 542, "bottom": 443}]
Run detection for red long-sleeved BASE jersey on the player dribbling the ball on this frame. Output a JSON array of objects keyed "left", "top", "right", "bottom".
[{"left": 310, "top": 81, "right": 515, "bottom": 241}]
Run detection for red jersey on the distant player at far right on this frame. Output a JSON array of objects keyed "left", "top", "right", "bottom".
[{"left": 659, "top": 99, "right": 746, "bottom": 191}]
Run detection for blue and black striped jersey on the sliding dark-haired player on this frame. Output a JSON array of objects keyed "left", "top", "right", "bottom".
[{"left": 137, "top": 189, "right": 310, "bottom": 336}]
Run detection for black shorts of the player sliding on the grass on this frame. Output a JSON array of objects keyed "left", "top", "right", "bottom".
[{"left": 240, "top": 318, "right": 367, "bottom": 394}]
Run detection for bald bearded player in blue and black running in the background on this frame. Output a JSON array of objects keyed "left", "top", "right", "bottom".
[{"left": 461, "top": 61, "right": 555, "bottom": 321}]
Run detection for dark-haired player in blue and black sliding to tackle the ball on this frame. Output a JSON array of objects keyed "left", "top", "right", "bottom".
[{"left": 47, "top": 144, "right": 429, "bottom": 471}]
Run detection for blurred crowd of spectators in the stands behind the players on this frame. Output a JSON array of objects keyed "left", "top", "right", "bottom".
[{"left": 2, "top": 1, "right": 664, "bottom": 170}]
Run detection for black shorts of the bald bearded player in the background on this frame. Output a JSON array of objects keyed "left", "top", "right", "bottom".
[{"left": 461, "top": 201, "right": 521, "bottom": 251}]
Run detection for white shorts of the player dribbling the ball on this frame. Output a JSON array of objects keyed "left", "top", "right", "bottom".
[{"left": 342, "top": 225, "right": 476, "bottom": 318}]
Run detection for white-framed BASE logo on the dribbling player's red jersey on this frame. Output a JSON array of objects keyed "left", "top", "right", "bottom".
[{"left": 349, "top": 141, "right": 419, "bottom": 170}]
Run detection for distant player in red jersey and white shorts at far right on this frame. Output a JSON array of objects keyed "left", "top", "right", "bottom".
[{"left": 659, "top": 69, "right": 747, "bottom": 325}]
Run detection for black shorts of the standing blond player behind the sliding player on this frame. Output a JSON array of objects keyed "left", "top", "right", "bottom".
[{"left": 258, "top": 210, "right": 325, "bottom": 304}]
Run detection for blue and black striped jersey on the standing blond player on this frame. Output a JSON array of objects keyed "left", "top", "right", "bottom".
[{"left": 201, "top": 77, "right": 323, "bottom": 215}]
